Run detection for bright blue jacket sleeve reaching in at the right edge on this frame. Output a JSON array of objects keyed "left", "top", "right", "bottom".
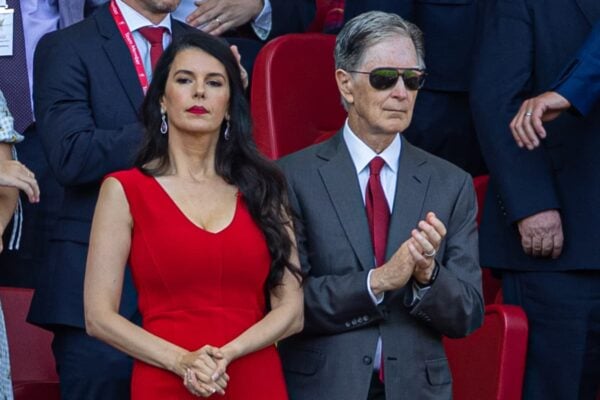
[{"left": 554, "top": 22, "right": 600, "bottom": 115}]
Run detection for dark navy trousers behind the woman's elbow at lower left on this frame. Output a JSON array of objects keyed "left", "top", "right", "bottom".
[{"left": 52, "top": 327, "right": 133, "bottom": 400}]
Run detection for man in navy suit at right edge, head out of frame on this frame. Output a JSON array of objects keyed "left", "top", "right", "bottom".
[{"left": 471, "top": 0, "right": 600, "bottom": 400}]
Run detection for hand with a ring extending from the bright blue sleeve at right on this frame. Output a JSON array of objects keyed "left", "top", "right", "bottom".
[{"left": 510, "top": 92, "right": 571, "bottom": 150}]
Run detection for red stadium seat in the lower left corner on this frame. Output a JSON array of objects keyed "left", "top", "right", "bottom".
[{"left": 0, "top": 287, "right": 60, "bottom": 400}]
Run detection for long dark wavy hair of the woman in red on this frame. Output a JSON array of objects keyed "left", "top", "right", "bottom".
[{"left": 135, "top": 32, "right": 301, "bottom": 291}]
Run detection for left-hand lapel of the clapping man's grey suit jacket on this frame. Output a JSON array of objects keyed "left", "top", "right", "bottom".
[{"left": 318, "top": 132, "right": 374, "bottom": 269}]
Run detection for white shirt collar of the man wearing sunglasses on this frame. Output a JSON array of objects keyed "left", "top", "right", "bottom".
[{"left": 343, "top": 119, "right": 402, "bottom": 175}]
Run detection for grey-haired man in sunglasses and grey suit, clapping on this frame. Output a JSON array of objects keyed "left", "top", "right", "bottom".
[{"left": 279, "top": 11, "right": 484, "bottom": 400}]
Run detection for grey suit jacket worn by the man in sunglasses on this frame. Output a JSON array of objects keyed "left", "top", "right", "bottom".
[{"left": 279, "top": 133, "right": 483, "bottom": 400}]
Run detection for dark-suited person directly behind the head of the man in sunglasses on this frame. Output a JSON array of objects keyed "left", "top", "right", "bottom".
[{"left": 344, "top": 0, "right": 487, "bottom": 175}]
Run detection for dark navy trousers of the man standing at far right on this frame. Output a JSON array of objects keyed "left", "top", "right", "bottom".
[{"left": 502, "top": 271, "right": 600, "bottom": 400}]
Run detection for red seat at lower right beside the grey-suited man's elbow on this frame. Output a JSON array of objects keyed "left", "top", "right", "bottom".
[{"left": 444, "top": 304, "right": 528, "bottom": 400}]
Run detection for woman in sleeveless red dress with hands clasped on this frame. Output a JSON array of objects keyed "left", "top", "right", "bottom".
[{"left": 85, "top": 33, "right": 303, "bottom": 400}]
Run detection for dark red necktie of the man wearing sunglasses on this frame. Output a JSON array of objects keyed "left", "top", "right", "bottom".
[{"left": 365, "top": 157, "right": 390, "bottom": 267}]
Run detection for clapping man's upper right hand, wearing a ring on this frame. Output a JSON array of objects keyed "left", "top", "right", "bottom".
[{"left": 408, "top": 212, "right": 446, "bottom": 285}]
